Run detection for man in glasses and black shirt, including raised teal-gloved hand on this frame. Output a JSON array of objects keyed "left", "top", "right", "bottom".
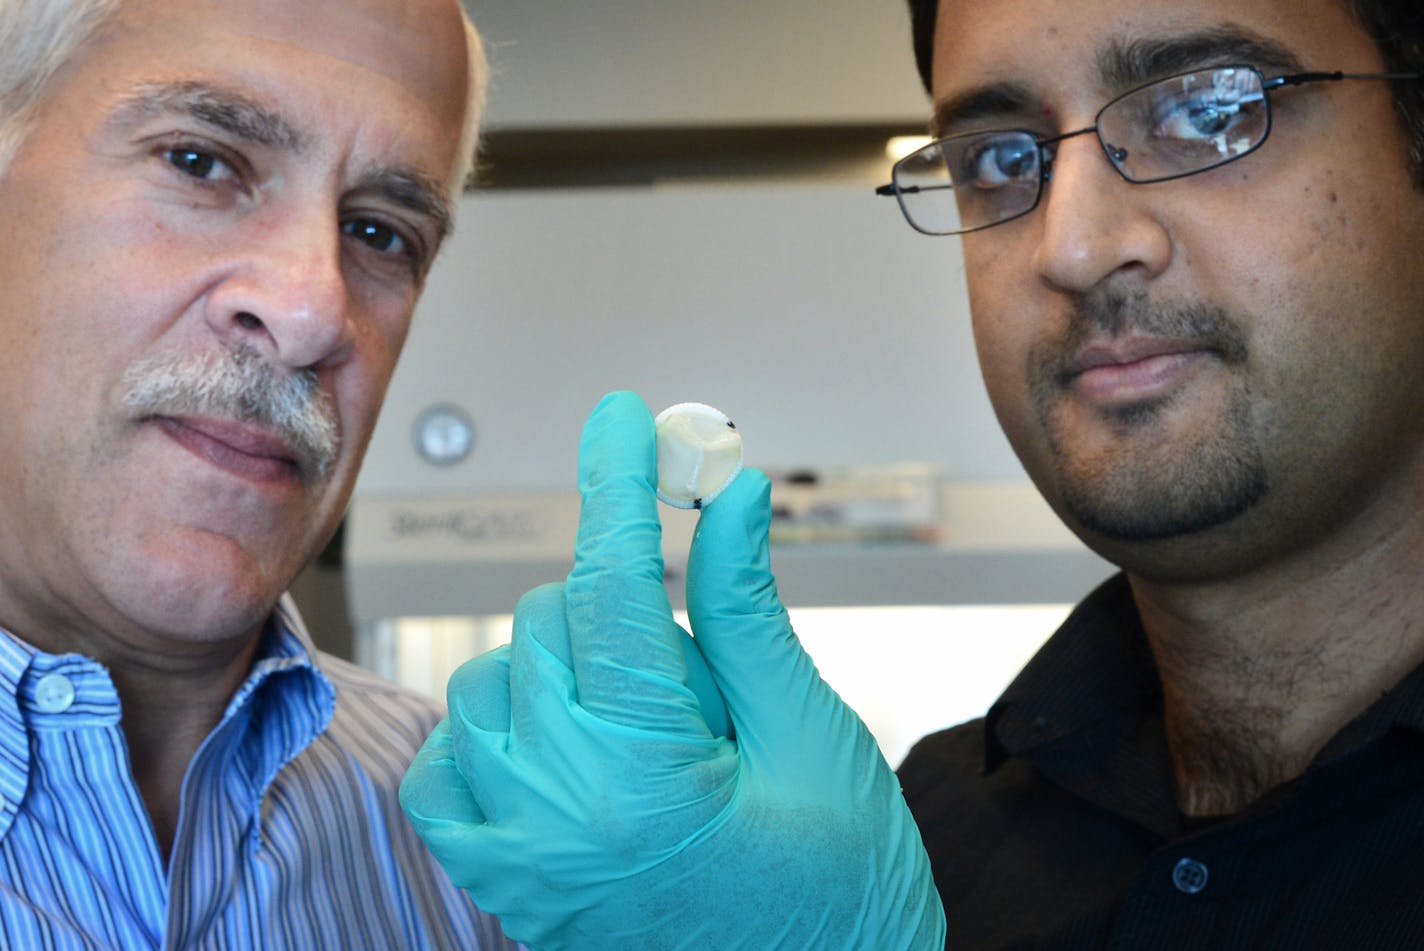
[{"left": 407, "top": 0, "right": 1424, "bottom": 948}]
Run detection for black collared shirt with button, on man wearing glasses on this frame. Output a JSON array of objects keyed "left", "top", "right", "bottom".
[{"left": 900, "top": 575, "right": 1424, "bottom": 951}]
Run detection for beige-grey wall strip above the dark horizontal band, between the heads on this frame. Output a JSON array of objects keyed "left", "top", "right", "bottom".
[{"left": 466, "top": 0, "right": 927, "bottom": 128}]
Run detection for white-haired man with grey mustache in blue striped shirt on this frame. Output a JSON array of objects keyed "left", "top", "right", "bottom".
[{"left": 0, "top": 0, "right": 515, "bottom": 950}]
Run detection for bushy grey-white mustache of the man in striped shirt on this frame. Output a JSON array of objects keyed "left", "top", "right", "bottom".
[{"left": 121, "top": 347, "right": 340, "bottom": 481}]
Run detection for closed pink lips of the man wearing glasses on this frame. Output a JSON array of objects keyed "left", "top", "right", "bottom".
[{"left": 1059, "top": 337, "right": 1218, "bottom": 404}]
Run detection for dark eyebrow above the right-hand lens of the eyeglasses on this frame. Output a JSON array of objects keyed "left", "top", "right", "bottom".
[{"left": 1098, "top": 24, "right": 1303, "bottom": 93}]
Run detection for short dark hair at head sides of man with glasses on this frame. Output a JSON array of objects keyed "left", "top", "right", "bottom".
[{"left": 909, "top": 0, "right": 1424, "bottom": 188}]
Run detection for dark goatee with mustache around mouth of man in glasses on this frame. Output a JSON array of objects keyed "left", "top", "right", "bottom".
[{"left": 1030, "top": 287, "right": 1270, "bottom": 541}]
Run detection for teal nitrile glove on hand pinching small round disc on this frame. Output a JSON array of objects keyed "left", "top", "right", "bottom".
[{"left": 402, "top": 393, "right": 944, "bottom": 951}]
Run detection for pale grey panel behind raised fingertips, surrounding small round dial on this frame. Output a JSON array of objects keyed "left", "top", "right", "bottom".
[{"left": 359, "top": 184, "right": 1024, "bottom": 494}]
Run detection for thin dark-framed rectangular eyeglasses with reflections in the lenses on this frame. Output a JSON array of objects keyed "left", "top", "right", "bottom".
[{"left": 876, "top": 65, "right": 1424, "bottom": 235}]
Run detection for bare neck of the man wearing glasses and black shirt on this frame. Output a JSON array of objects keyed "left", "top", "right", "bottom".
[{"left": 1132, "top": 512, "right": 1424, "bottom": 816}]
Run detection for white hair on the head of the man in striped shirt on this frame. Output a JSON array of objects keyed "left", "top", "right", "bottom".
[{"left": 0, "top": 0, "right": 490, "bottom": 192}]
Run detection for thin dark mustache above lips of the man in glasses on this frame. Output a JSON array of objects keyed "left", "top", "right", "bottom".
[{"left": 1031, "top": 290, "right": 1249, "bottom": 382}]
